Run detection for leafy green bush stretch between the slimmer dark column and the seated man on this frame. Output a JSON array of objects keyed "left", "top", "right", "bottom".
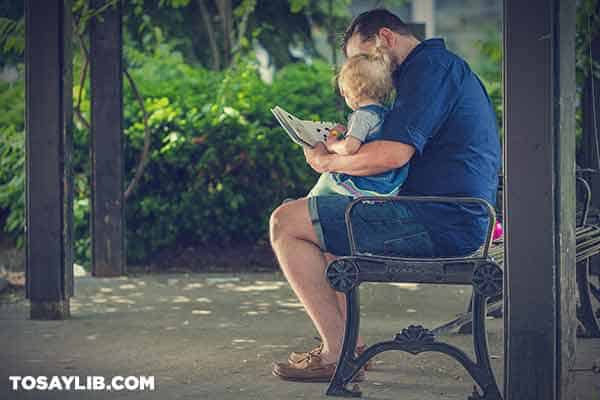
[{"left": 125, "top": 48, "right": 336, "bottom": 261}]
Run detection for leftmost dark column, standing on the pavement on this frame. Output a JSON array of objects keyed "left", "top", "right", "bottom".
[{"left": 25, "top": 0, "right": 73, "bottom": 319}]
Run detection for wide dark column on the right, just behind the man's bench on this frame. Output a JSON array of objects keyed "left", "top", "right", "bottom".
[{"left": 504, "top": 0, "right": 576, "bottom": 400}]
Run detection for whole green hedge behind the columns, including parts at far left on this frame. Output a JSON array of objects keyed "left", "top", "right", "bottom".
[{"left": 0, "top": 45, "right": 341, "bottom": 264}]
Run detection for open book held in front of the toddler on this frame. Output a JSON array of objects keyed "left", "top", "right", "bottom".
[{"left": 271, "top": 106, "right": 337, "bottom": 147}]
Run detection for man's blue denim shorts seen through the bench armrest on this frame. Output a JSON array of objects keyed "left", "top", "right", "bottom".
[{"left": 308, "top": 195, "right": 435, "bottom": 257}]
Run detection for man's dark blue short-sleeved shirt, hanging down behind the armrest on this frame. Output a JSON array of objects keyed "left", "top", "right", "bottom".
[{"left": 382, "top": 39, "right": 500, "bottom": 256}]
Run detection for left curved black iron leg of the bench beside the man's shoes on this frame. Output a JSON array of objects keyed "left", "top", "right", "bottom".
[{"left": 327, "top": 287, "right": 366, "bottom": 397}]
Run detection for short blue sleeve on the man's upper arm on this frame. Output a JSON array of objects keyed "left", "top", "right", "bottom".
[{"left": 382, "top": 56, "right": 465, "bottom": 154}]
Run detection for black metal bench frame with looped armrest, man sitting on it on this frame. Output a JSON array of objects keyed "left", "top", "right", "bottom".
[{"left": 326, "top": 196, "right": 503, "bottom": 400}]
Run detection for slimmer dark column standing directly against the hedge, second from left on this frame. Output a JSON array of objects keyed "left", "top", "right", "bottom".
[{"left": 90, "top": 0, "right": 125, "bottom": 276}]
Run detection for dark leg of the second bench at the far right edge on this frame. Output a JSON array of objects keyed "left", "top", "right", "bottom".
[{"left": 576, "top": 258, "right": 600, "bottom": 338}]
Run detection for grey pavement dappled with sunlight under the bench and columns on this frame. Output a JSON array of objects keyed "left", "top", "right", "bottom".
[{"left": 0, "top": 274, "right": 600, "bottom": 400}]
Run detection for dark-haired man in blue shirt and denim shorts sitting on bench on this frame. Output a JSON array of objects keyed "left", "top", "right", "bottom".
[{"left": 270, "top": 9, "right": 500, "bottom": 381}]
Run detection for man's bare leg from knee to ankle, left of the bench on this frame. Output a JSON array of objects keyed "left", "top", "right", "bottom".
[{"left": 270, "top": 199, "right": 362, "bottom": 363}]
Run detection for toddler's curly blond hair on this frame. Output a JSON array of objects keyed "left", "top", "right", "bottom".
[{"left": 337, "top": 48, "right": 394, "bottom": 103}]
